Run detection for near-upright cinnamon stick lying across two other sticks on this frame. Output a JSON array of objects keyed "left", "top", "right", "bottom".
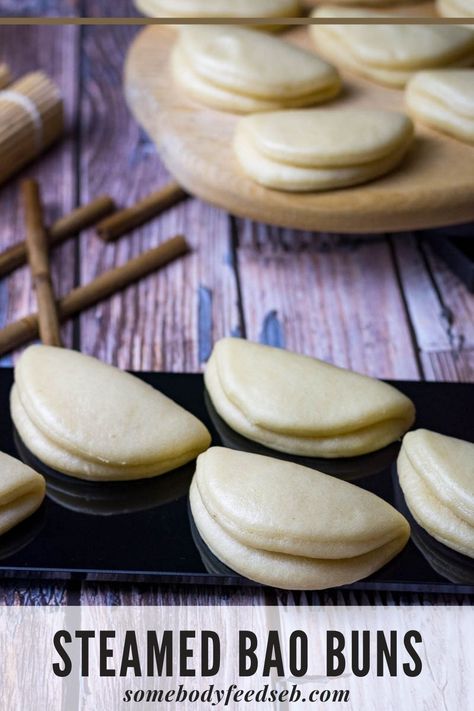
[{"left": 21, "top": 180, "right": 62, "bottom": 346}]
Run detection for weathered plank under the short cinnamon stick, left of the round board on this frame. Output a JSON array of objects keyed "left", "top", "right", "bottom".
[{"left": 81, "top": 12, "right": 238, "bottom": 370}]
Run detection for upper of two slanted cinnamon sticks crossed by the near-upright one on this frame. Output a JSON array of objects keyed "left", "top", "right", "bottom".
[{"left": 0, "top": 195, "right": 116, "bottom": 277}]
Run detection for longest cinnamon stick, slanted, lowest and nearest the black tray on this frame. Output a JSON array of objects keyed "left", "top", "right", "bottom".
[{"left": 0, "top": 236, "right": 189, "bottom": 355}]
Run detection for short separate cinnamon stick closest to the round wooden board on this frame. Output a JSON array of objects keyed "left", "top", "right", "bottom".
[{"left": 97, "top": 182, "right": 187, "bottom": 242}]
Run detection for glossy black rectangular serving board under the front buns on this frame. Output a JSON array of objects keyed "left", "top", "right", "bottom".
[{"left": 0, "top": 369, "right": 474, "bottom": 593}]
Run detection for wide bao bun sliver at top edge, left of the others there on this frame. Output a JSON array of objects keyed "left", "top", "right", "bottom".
[{"left": 135, "top": 0, "right": 301, "bottom": 18}]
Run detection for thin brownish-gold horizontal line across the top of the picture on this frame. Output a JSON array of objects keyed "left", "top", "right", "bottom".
[{"left": 0, "top": 16, "right": 474, "bottom": 27}]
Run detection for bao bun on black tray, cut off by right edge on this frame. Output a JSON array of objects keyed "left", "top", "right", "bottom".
[{"left": 398, "top": 430, "right": 474, "bottom": 558}]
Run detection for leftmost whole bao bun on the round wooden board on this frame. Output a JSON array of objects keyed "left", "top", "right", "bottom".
[{"left": 171, "top": 25, "right": 341, "bottom": 113}]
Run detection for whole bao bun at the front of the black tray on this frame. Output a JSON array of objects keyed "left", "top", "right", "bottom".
[{"left": 190, "top": 447, "right": 410, "bottom": 590}]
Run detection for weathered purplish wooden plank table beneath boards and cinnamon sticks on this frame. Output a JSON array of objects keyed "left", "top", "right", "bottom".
[{"left": 0, "top": 0, "right": 474, "bottom": 605}]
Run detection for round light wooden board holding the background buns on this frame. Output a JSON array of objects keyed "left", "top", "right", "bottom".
[{"left": 125, "top": 25, "right": 474, "bottom": 234}]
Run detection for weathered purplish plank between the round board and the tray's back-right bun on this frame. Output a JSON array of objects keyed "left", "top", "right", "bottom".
[{"left": 238, "top": 222, "right": 420, "bottom": 379}]
